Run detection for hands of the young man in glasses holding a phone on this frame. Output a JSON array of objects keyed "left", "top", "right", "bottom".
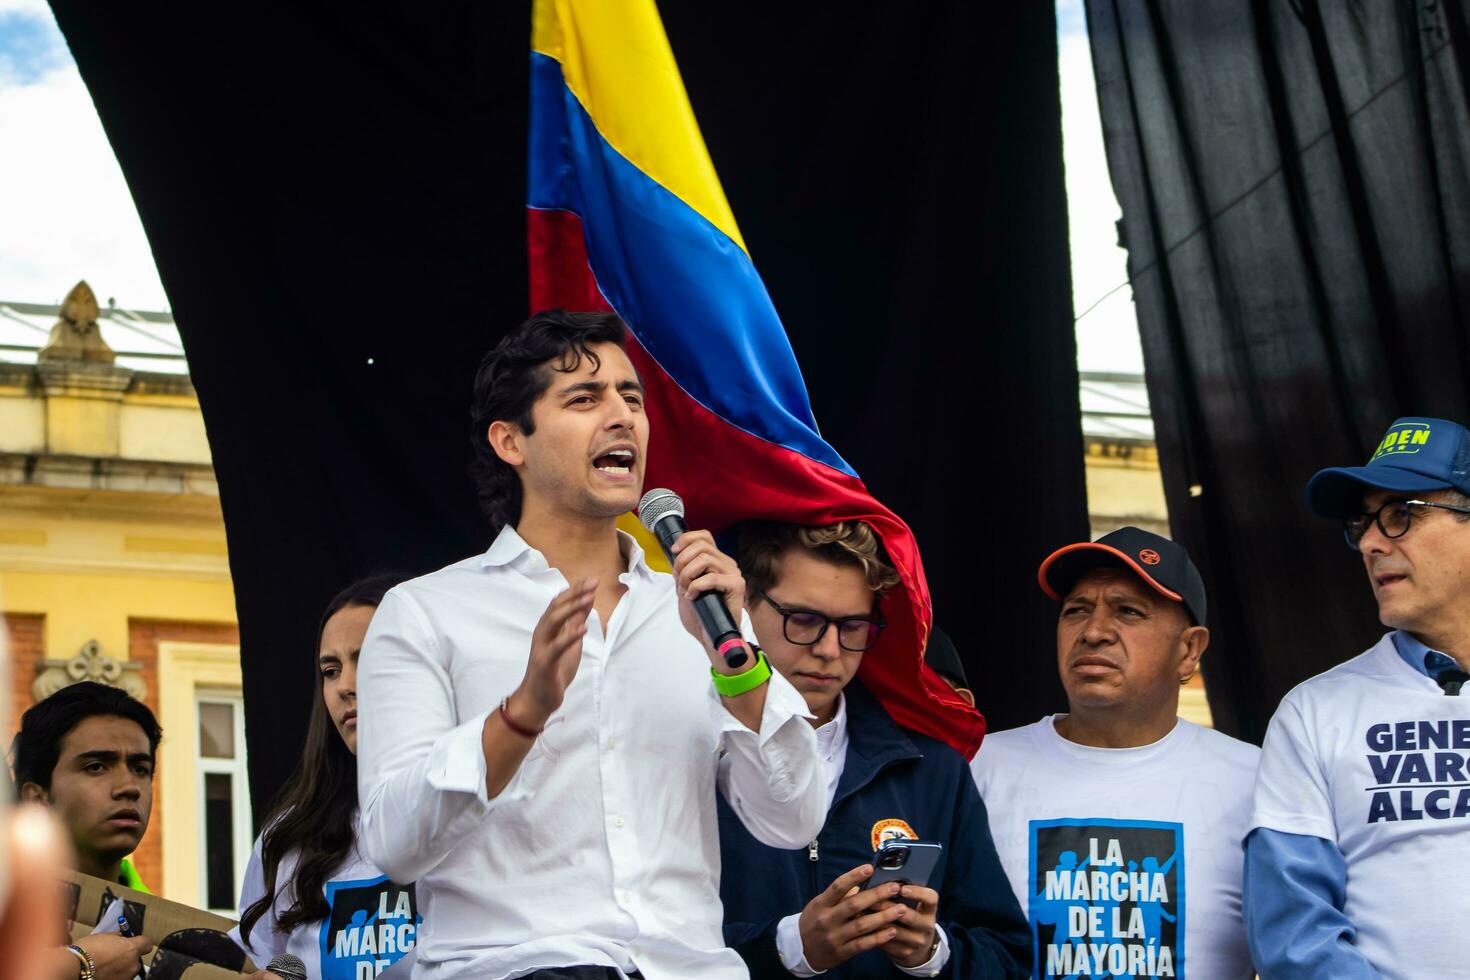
[{"left": 797, "top": 864, "right": 905, "bottom": 971}]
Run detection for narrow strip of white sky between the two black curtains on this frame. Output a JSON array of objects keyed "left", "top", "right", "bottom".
[{"left": 1057, "top": 0, "right": 1144, "bottom": 372}]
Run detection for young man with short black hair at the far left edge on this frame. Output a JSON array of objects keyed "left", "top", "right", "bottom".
[{"left": 10, "top": 680, "right": 163, "bottom": 980}]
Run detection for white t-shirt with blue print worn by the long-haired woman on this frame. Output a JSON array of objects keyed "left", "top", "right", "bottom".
[{"left": 229, "top": 835, "right": 422, "bottom": 980}]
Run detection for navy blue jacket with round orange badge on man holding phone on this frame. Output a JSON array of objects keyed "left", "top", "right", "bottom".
[{"left": 719, "top": 680, "right": 1032, "bottom": 980}]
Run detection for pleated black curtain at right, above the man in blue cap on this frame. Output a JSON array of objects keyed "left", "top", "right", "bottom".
[{"left": 1086, "top": 0, "right": 1470, "bottom": 742}]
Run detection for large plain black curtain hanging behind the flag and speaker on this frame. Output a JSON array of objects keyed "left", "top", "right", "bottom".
[{"left": 53, "top": 0, "right": 1086, "bottom": 815}]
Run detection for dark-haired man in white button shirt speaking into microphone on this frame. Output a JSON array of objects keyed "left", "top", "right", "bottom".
[{"left": 357, "top": 310, "right": 826, "bottom": 980}]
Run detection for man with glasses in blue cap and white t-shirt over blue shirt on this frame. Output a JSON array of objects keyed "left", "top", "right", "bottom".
[{"left": 1245, "top": 417, "right": 1470, "bottom": 980}]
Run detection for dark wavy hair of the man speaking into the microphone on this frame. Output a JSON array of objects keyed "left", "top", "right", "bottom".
[{"left": 469, "top": 310, "right": 628, "bottom": 533}]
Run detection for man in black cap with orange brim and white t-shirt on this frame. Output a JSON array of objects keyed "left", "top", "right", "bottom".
[{"left": 972, "top": 527, "right": 1258, "bottom": 980}]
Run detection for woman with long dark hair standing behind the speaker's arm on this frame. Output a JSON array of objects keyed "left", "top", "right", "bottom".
[{"left": 234, "top": 576, "right": 419, "bottom": 980}]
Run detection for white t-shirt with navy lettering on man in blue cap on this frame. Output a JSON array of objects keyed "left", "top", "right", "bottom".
[{"left": 1251, "top": 631, "right": 1470, "bottom": 980}]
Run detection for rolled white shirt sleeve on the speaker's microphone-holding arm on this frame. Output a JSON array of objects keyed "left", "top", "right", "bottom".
[{"left": 710, "top": 670, "right": 828, "bottom": 849}]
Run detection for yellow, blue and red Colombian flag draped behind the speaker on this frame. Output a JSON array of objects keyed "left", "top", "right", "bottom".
[{"left": 528, "top": 0, "right": 985, "bottom": 757}]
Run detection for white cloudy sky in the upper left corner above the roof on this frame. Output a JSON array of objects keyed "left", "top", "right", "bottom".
[{"left": 0, "top": 0, "right": 168, "bottom": 310}]
